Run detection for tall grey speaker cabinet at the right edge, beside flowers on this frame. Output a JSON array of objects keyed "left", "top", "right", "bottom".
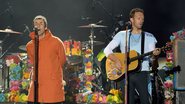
[{"left": 173, "top": 40, "right": 185, "bottom": 91}]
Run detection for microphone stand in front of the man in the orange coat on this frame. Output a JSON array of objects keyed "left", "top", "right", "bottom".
[{"left": 34, "top": 28, "right": 39, "bottom": 104}]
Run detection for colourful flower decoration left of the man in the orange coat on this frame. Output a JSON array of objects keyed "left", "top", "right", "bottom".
[{"left": 0, "top": 53, "right": 33, "bottom": 102}]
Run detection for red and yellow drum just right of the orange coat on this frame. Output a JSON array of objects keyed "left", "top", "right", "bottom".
[{"left": 64, "top": 39, "right": 82, "bottom": 65}]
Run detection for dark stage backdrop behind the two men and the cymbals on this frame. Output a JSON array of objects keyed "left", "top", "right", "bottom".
[{"left": 0, "top": 0, "right": 185, "bottom": 56}]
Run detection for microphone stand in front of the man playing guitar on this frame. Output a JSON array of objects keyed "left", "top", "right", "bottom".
[{"left": 124, "top": 25, "right": 130, "bottom": 104}]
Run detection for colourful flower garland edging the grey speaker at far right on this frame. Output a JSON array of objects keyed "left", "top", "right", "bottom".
[{"left": 163, "top": 29, "right": 185, "bottom": 104}]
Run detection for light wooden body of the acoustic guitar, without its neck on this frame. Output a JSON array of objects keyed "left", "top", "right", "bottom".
[{"left": 106, "top": 50, "right": 138, "bottom": 80}]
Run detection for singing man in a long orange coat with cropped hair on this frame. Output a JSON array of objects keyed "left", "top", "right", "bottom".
[{"left": 26, "top": 15, "right": 66, "bottom": 104}]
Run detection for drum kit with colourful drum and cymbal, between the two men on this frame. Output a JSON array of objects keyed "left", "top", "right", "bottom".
[{"left": 64, "top": 24, "right": 107, "bottom": 93}]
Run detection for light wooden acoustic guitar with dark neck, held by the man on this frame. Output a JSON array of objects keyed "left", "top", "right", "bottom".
[{"left": 106, "top": 45, "right": 171, "bottom": 80}]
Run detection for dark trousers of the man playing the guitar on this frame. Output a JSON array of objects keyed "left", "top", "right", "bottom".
[{"left": 128, "top": 71, "right": 150, "bottom": 104}]
